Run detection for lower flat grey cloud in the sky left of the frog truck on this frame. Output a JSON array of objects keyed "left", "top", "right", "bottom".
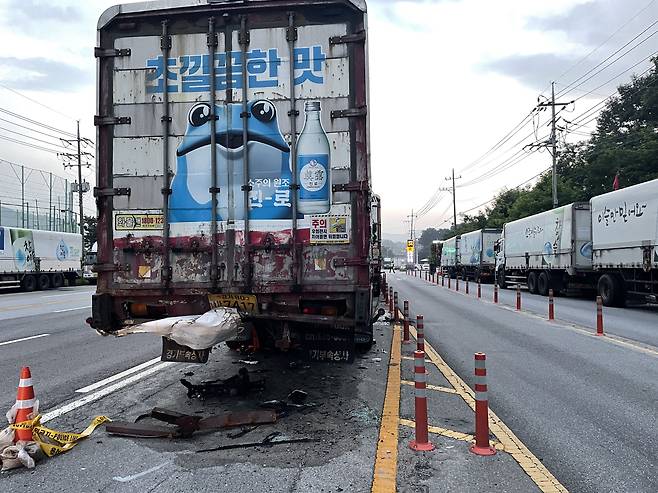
[{"left": 0, "top": 57, "right": 92, "bottom": 92}]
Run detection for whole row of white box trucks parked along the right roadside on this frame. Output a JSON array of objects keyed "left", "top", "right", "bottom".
[{"left": 440, "top": 180, "right": 658, "bottom": 306}]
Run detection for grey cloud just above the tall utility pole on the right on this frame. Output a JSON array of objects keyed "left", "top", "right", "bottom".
[{"left": 483, "top": 53, "right": 578, "bottom": 90}]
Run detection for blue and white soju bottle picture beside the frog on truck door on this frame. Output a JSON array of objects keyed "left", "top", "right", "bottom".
[{"left": 297, "top": 101, "right": 331, "bottom": 214}]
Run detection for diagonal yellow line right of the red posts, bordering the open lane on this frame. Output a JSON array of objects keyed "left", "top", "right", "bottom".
[{"left": 410, "top": 328, "right": 568, "bottom": 493}]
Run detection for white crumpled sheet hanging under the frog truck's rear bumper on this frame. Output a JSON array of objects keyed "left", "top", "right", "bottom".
[{"left": 115, "top": 307, "right": 242, "bottom": 349}]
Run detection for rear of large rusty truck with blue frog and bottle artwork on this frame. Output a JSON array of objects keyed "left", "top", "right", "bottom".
[{"left": 90, "top": 0, "right": 381, "bottom": 361}]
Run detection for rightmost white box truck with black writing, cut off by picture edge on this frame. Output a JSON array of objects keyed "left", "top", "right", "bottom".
[{"left": 590, "top": 180, "right": 658, "bottom": 305}]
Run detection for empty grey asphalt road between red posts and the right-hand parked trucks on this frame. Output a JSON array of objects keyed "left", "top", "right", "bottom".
[{"left": 387, "top": 273, "right": 658, "bottom": 492}]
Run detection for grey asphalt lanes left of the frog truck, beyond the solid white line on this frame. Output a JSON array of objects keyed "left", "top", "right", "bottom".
[{"left": 0, "top": 286, "right": 160, "bottom": 415}]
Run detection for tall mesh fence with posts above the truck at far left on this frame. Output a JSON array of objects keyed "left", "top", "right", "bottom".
[{"left": 0, "top": 159, "right": 80, "bottom": 233}]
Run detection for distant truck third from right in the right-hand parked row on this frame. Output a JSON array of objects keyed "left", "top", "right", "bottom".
[{"left": 458, "top": 228, "right": 501, "bottom": 282}]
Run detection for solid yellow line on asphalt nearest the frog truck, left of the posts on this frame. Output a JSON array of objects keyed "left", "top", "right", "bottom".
[{"left": 372, "top": 325, "right": 401, "bottom": 493}]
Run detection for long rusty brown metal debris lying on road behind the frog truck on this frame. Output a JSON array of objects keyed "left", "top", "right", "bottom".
[{"left": 106, "top": 407, "right": 277, "bottom": 438}]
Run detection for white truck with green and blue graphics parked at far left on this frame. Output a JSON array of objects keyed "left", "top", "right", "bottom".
[{"left": 0, "top": 226, "right": 82, "bottom": 291}]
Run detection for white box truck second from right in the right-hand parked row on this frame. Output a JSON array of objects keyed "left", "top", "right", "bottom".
[{"left": 496, "top": 202, "right": 592, "bottom": 296}]
